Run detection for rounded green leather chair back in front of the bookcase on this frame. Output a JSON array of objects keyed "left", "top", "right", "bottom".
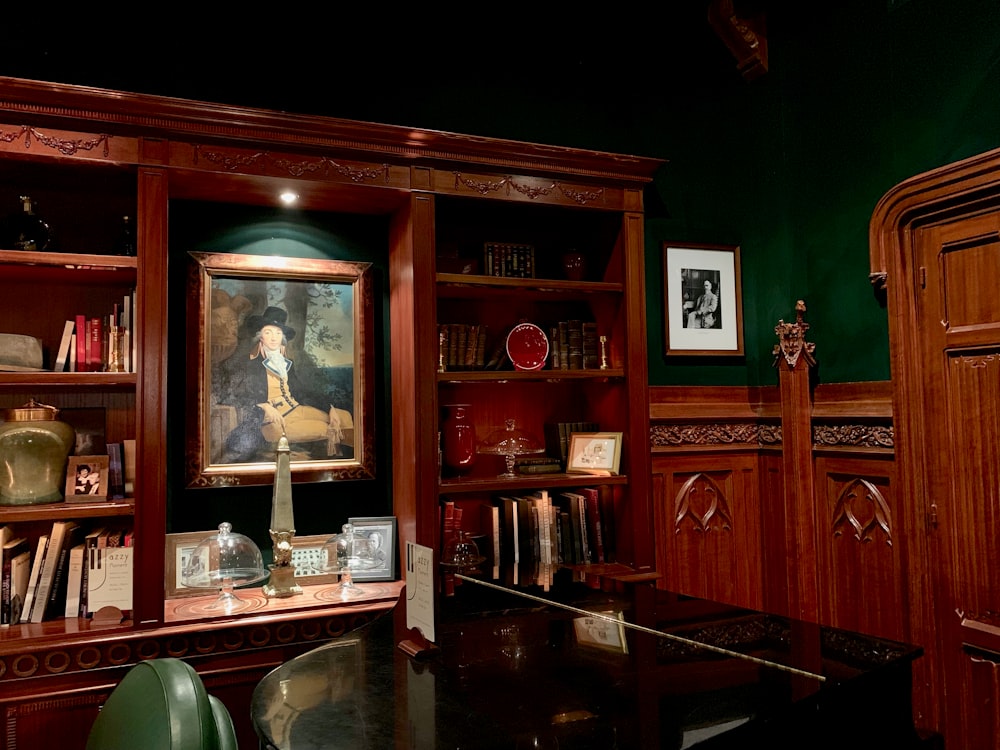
[{"left": 87, "top": 658, "right": 238, "bottom": 750}]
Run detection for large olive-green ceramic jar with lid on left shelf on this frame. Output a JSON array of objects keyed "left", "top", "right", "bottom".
[{"left": 0, "top": 399, "right": 76, "bottom": 505}]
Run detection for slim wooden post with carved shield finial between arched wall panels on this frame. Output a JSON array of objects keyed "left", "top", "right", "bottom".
[{"left": 774, "top": 300, "right": 819, "bottom": 622}]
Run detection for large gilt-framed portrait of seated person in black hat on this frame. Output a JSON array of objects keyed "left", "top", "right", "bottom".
[{"left": 185, "top": 253, "right": 375, "bottom": 487}]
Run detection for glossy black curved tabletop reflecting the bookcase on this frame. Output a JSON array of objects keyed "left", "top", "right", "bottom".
[{"left": 252, "top": 582, "right": 923, "bottom": 750}]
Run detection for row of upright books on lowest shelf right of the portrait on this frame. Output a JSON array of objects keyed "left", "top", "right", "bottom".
[{"left": 442, "top": 485, "right": 616, "bottom": 594}]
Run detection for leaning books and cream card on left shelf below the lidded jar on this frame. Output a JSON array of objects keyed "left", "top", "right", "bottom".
[{"left": 0, "top": 520, "right": 134, "bottom": 627}]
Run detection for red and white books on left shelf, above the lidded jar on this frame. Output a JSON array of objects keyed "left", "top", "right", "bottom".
[{"left": 52, "top": 289, "right": 136, "bottom": 372}]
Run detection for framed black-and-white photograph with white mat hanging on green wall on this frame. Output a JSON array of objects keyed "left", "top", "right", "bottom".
[{"left": 663, "top": 242, "right": 743, "bottom": 357}]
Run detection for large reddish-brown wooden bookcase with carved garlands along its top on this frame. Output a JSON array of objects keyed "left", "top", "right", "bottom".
[{"left": 0, "top": 78, "right": 661, "bottom": 748}]
